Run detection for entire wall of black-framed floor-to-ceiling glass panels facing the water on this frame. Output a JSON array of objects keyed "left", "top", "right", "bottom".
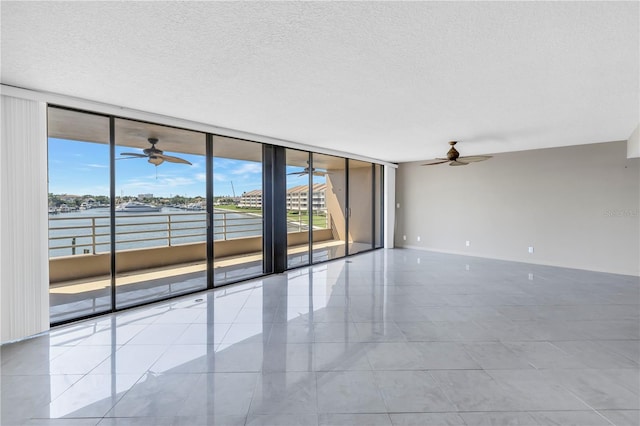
[{"left": 48, "top": 107, "right": 383, "bottom": 324}]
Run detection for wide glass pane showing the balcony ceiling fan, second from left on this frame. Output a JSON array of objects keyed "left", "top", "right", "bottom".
[{"left": 115, "top": 119, "right": 207, "bottom": 308}]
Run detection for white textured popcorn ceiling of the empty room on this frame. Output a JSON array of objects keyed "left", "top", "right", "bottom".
[{"left": 0, "top": 1, "right": 640, "bottom": 162}]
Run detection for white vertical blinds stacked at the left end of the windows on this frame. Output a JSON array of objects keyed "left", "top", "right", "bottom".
[{"left": 0, "top": 95, "right": 49, "bottom": 342}]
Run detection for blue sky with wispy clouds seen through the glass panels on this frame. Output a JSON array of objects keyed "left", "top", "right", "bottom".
[{"left": 49, "top": 138, "right": 320, "bottom": 197}]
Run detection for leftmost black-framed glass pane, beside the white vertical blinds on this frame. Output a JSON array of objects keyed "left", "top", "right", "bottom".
[{"left": 48, "top": 107, "right": 111, "bottom": 324}]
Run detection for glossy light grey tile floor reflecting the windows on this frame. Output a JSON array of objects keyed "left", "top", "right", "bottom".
[{"left": 0, "top": 249, "right": 640, "bottom": 426}]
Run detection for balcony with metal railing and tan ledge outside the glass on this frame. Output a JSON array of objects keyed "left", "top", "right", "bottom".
[{"left": 49, "top": 211, "right": 345, "bottom": 323}]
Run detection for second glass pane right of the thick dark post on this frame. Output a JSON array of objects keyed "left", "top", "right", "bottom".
[{"left": 311, "top": 154, "right": 347, "bottom": 263}]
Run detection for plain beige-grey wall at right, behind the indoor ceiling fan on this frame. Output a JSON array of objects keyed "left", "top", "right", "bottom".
[{"left": 395, "top": 141, "right": 640, "bottom": 275}]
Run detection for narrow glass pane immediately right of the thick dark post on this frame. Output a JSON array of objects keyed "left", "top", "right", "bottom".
[{"left": 286, "top": 149, "right": 312, "bottom": 268}]
